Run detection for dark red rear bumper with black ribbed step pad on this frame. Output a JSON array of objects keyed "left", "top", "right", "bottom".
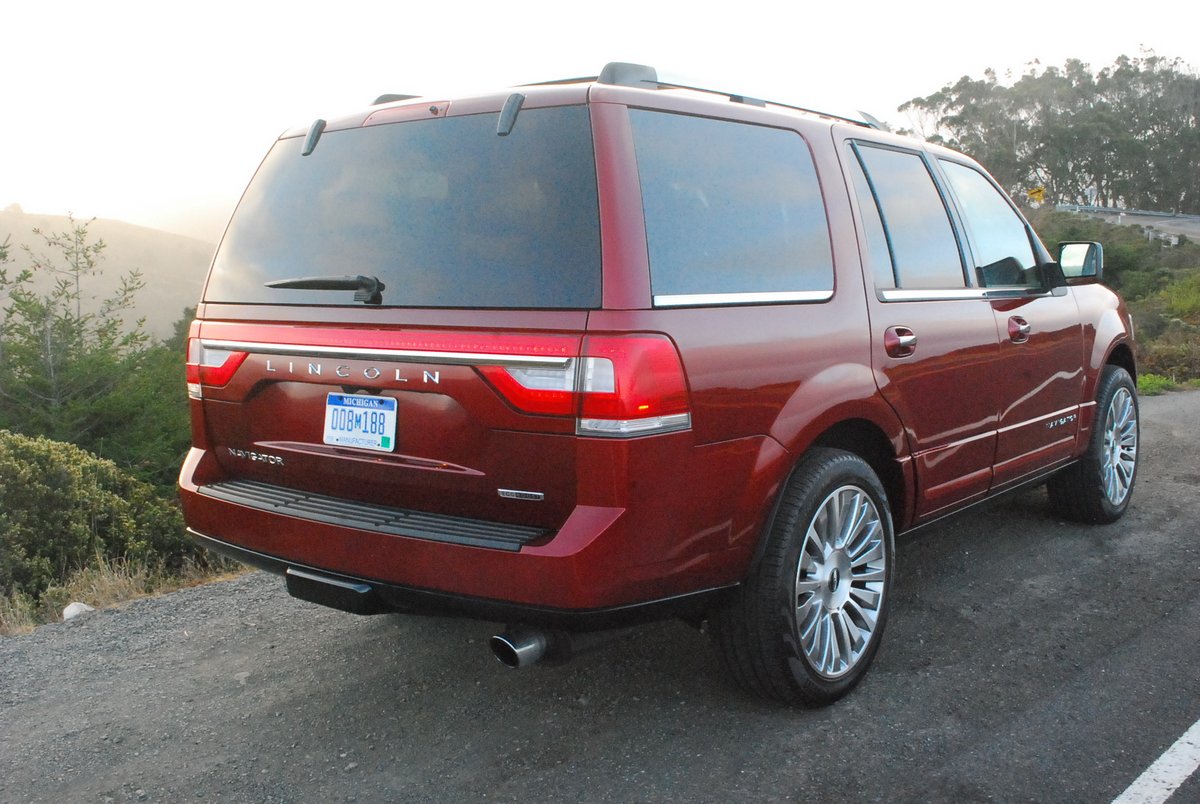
[{"left": 179, "top": 449, "right": 748, "bottom": 630}]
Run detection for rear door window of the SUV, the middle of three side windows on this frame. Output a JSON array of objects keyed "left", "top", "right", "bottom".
[{"left": 854, "top": 143, "right": 966, "bottom": 289}]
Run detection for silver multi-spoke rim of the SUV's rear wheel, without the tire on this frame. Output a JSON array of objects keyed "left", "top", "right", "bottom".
[{"left": 794, "top": 486, "right": 888, "bottom": 678}]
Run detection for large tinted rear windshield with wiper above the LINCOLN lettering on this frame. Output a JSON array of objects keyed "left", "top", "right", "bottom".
[{"left": 205, "top": 107, "right": 609, "bottom": 307}]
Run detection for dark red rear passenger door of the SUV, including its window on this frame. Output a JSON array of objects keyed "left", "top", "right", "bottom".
[{"left": 844, "top": 140, "right": 1001, "bottom": 518}]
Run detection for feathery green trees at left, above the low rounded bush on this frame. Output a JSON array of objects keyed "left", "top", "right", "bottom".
[{"left": 0, "top": 218, "right": 190, "bottom": 491}]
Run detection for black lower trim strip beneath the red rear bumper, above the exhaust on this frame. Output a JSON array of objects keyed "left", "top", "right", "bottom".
[{"left": 188, "top": 528, "right": 724, "bottom": 631}]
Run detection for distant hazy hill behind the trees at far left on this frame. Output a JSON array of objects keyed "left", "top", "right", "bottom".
[{"left": 0, "top": 208, "right": 216, "bottom": 337}]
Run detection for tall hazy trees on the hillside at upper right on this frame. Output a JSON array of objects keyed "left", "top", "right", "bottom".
[{"left": 900, "top": 53, "right": 1200, "bottom": 212}]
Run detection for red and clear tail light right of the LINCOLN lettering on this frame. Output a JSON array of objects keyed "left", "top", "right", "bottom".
[{"left": 478, "top": 335, "right": 691, "bottom": 438}]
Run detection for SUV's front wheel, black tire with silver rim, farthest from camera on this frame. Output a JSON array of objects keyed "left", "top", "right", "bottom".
[{"left": 1046, "top": 366, "right": 1139, "bottom": 524}]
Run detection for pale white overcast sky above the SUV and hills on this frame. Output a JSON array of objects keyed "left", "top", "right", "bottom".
[{"left": 0, "top": 0, "right": 1200, "bottom": 242}]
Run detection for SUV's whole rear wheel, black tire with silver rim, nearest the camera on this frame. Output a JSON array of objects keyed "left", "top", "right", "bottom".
[{"left": 709, "top": 449, "right": 895, "bottom": 706}]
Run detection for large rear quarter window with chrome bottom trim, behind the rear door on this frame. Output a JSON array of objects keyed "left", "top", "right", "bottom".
[{"left": 630, "top": 109, "right": 833, "bottom": 306}]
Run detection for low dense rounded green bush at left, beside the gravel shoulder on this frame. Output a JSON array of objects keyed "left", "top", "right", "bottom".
[{"left": 0, "top": 430, "right": 199, "bottom": 598}]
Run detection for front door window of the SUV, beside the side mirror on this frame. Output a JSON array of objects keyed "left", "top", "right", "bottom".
[{"left": 941, "top": 160, "right": 1039, "bottom": 287}]
